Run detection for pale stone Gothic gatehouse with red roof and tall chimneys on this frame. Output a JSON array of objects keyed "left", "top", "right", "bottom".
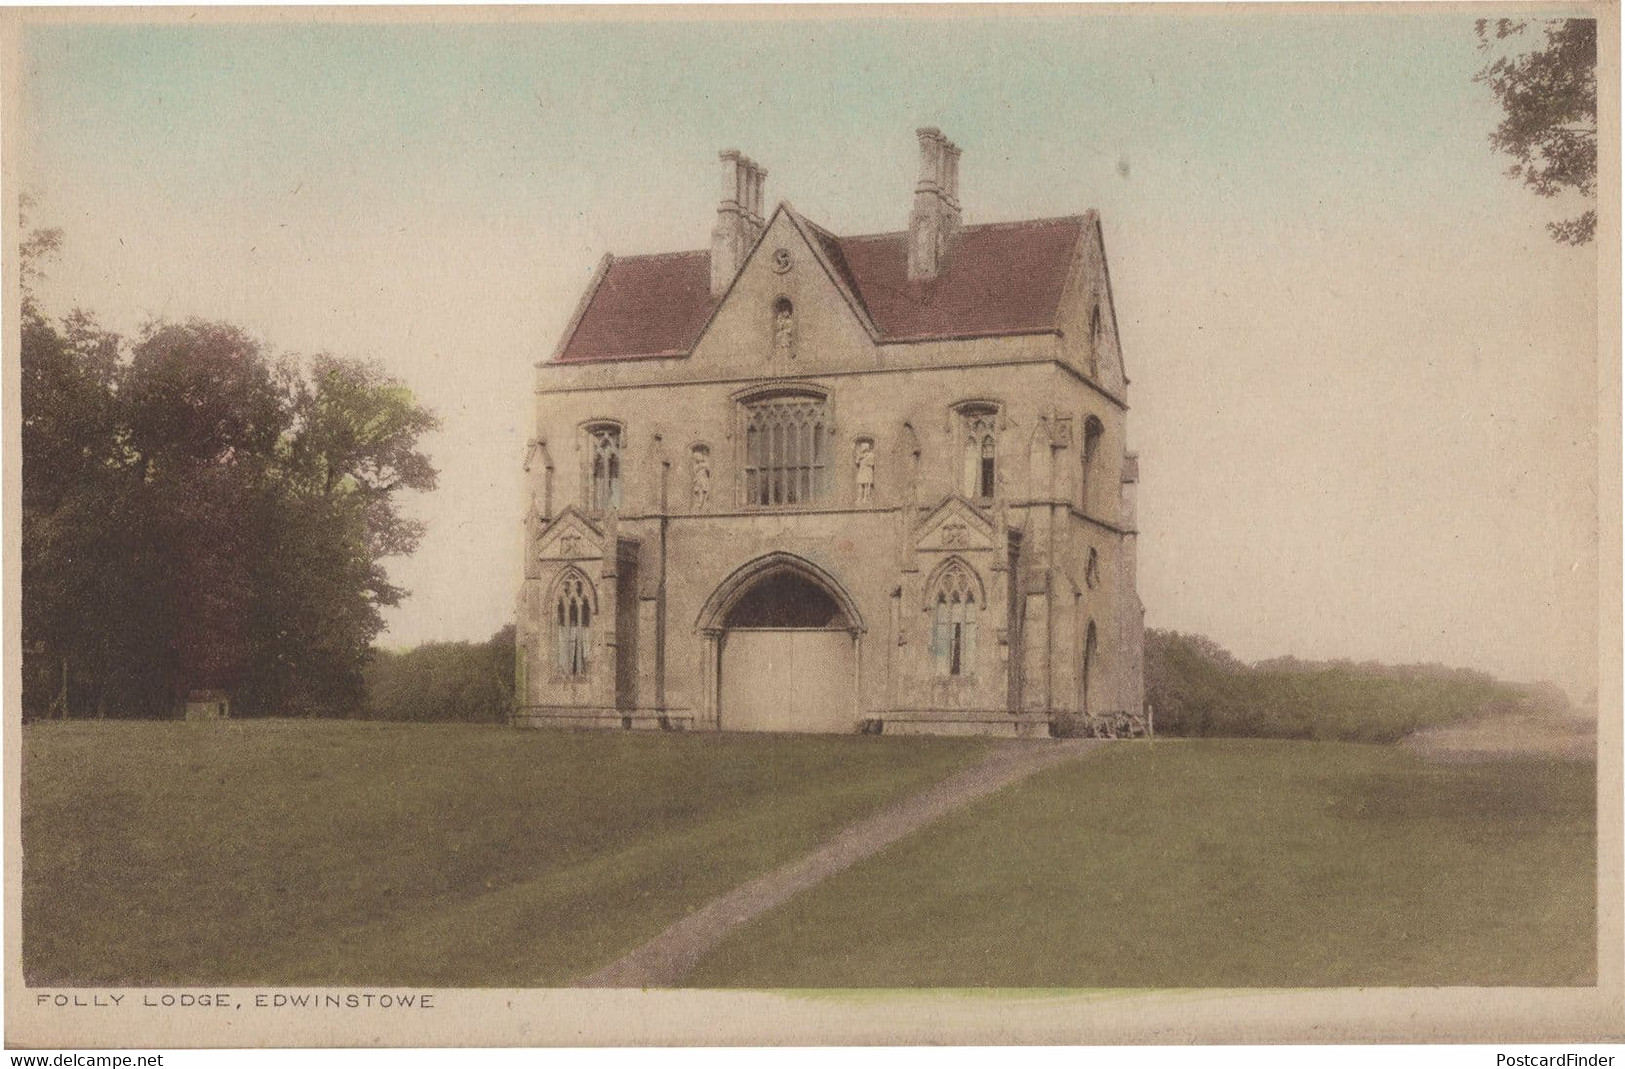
[{"left": 515, "top": 128, "right": 1144, "bottom": 736}]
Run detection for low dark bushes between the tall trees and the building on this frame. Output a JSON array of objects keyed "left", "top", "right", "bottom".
[{"left": 366, "top": 624, "right": 514, "bottom": 723}]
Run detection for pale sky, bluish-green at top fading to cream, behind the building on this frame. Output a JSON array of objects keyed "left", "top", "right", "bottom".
[{"left": 20, "top": 5, "right": 1597, "bottom": 697}]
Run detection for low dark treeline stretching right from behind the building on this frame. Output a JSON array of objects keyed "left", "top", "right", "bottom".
[{"left": 1146, "top": 629, "right": 1568, "bottom": 742}]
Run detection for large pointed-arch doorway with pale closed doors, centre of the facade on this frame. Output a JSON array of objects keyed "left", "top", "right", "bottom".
[{"left": 702, "top": 554, "right": 861, "bottom": 733}]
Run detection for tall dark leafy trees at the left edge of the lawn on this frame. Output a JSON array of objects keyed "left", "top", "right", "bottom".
[{"left": 21, "top": 219, "right": 436, "bottom": 718}]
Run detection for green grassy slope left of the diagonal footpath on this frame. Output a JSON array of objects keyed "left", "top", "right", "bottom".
[{"left": 23, "top": 721, "right": 983, "bottom": 986}]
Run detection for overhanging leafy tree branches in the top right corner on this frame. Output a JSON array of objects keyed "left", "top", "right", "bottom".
[{"left": 1474, "top": 18, "right": 1597, "bottom": 245}]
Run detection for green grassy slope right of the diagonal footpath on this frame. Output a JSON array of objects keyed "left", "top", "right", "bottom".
[{"left": 689, "top": 741, "right": 1596, "bottom": 988}]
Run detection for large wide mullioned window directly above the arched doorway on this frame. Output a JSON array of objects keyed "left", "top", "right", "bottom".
[{"left": 744, "top": 393, "right": 830, "bottom": 505}]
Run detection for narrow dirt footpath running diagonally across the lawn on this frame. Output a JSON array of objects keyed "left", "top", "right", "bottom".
[{"left": 575, "top": 739, "right": 1103, "bottom": 988}]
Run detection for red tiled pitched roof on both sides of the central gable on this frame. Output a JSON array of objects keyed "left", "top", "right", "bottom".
[{"left": 557, "top": 216, "right": 1086, "bottom": 364}]
